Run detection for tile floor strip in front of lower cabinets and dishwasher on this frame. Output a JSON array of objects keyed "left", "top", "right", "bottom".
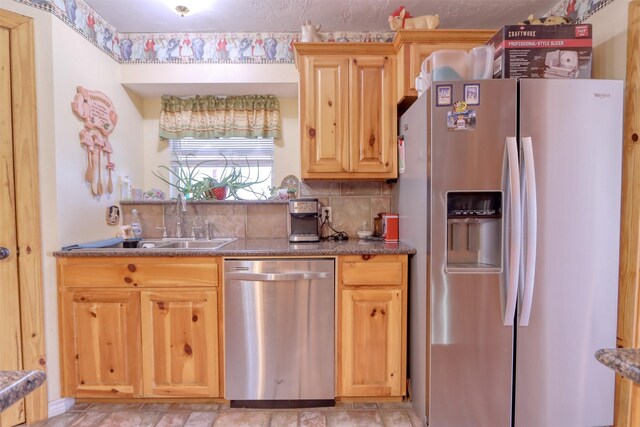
[{"left": 32, "top": 402, "right": 424, "bottom": 427}]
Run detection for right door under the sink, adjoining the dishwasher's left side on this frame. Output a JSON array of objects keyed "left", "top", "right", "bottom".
[{"left": 141, "top": 289, "right": 220, "bottom": 397}]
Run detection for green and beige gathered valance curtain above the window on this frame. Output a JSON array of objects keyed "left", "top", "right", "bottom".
[{"left": 160, "top": 95, "right": 280, "bottom": 139}]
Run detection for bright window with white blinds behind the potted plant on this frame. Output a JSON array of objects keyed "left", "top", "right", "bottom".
[{"left": 169, "top": 138, "right": 273, "bottom": 200}]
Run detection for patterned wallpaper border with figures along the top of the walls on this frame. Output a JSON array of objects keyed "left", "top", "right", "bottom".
[{"left": 14, "top": 0, "right": 613, "bottom": 64}]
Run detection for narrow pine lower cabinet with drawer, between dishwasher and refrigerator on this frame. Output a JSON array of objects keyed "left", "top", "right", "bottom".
[{"left": 338, "top": 255, "right": 407, "bottom": 398}]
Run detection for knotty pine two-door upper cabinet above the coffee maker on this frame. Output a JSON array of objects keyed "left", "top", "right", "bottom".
[{"left": 296, "top": 43, "right": 397, "bottom": 180}]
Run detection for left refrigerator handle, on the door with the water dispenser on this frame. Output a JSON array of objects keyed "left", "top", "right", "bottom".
[{"left": 503, "top": 136, "right": 522, "bottom": 326}]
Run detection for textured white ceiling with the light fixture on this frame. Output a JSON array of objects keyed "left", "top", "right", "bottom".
[{"left": 85, "top": 0, "right": 559, "bottom": 33}]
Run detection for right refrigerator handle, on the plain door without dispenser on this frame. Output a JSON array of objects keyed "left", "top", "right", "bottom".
[{"left": 520, "top": 136, "right": 538, "bottom": 326}]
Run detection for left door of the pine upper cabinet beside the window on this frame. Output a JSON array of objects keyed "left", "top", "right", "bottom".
[{"left": 300, "top": 56, "right": 349, "bottom": 178}]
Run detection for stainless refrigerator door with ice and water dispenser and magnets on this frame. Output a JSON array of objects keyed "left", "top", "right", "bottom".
[{"left": 423, "top": 80, "right": 516, "bottom": 427}]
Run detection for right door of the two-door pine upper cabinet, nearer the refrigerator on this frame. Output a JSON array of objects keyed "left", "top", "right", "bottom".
[{"left": 349, "top": 55, "right": 397, "bottom": 178}]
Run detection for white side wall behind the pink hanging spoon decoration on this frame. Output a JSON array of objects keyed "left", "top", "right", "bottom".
[{"left": 51, "top": 19, "right": 144, "bottom": 245}]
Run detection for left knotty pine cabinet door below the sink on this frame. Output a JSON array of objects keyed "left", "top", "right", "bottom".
[{"left": 60, "top": 289, "right": 142, "bottom": 398}]
